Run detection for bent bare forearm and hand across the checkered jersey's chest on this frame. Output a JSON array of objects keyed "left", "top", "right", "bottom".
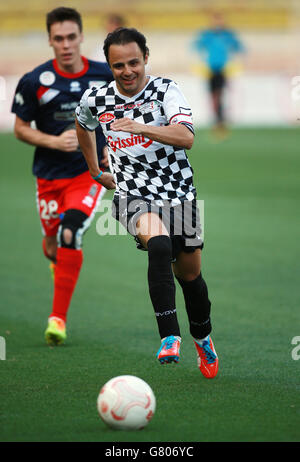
[{"left": 110, "top": 117, "right": 194, "bottom": 149}]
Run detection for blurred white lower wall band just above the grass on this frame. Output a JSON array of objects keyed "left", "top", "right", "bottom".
[{"left": 0, "top": 73, "right": 294, "bottom": 132}]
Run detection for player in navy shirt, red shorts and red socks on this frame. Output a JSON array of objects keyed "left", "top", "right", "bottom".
[{"left": 12, "top": 7, "right": 112, "bottom": 345}]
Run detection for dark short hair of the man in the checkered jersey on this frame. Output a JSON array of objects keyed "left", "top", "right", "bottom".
[{"left": 103, "top": 27, "right": 149, "bottom": 64}]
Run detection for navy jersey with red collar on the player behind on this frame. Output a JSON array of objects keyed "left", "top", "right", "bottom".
[{"left": 12, "top": 56, "right": 113, "bottom": 180}]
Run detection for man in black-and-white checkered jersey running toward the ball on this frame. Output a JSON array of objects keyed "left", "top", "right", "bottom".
[{"left": 76, "top": 28, "right": 218, "bottom": 378}]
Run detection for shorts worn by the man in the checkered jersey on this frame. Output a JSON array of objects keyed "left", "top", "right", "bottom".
[{"left": 112, "top": 194, "right": 204, "bottom": 261}]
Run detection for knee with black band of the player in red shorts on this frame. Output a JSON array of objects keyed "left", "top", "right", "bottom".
[{"left": 57, "top": 209, "right": 88, "bottom": 249}]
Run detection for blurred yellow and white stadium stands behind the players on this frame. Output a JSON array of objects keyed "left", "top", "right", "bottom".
[{"left": 0, "top": 0, "right": 300, "bottom": 131}]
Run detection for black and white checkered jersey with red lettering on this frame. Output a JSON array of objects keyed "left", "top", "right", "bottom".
[{"left": 76, "top": 76, "right": 196, "bottom": 206}]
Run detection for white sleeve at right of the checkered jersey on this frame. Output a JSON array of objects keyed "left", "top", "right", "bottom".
[{"left": 163, "top": 82, "right": 194, "bottom": 134}]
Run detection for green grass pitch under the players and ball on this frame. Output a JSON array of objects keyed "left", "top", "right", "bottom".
[{"left": 0, "top": 128, "right": 300, "bottom": 442}]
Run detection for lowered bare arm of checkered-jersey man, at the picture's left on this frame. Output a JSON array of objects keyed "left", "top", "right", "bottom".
[{"left": 75, "top": 120, "right": 116, "bottom": 189}]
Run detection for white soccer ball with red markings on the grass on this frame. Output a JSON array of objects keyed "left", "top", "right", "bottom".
[{"left": 97, "top": 375, "right": 156, "bottom": 430}]
